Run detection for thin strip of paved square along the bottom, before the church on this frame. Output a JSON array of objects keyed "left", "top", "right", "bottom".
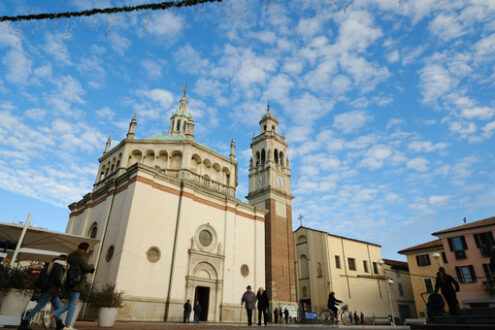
[{"left": 33, "top": 322, "right": 410, "bottom": 330}]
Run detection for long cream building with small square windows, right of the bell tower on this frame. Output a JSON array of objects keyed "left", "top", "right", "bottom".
[{"left": 294, "top": 227, "right": 397, "bottom": 317}]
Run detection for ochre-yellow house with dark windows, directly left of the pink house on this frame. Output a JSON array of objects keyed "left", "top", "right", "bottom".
[{"left": 399, "top": 239, "right": 449, "bottom": 317}]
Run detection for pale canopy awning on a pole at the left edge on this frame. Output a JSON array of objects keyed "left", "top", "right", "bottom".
[{"left": 0, "top": 222, "right": 99, "bottom": 261}]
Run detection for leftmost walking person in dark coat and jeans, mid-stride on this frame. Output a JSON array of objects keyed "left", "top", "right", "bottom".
[{"left": 17, "top": 254, "right": 67, "bottom": 330}]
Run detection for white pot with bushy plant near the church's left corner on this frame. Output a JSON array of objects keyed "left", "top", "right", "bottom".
[{"left": 89, "top": 284, "right": 124, "bottom": 327}]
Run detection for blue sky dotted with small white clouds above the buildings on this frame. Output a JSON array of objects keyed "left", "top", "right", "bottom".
[{"left": 0, "top": 0, "right": 495, "bottom": 259}]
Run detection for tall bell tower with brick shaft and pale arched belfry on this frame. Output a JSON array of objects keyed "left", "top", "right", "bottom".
[{"left": 246, "top": 105, "right": 296, "bottom": 305}]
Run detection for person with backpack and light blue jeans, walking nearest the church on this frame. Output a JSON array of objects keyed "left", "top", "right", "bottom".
[{"left": 50, "top": 242, "right": 95, "bottom": 330}]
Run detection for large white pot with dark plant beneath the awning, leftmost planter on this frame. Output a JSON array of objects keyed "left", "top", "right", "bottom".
[{"left": 0, "top": 266, "right": 35, "bottom": 316}]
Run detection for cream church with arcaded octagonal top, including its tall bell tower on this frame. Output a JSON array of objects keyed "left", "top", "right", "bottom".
[{"left": 66, "top": 90, "right": 296, "bottom": 322}]
